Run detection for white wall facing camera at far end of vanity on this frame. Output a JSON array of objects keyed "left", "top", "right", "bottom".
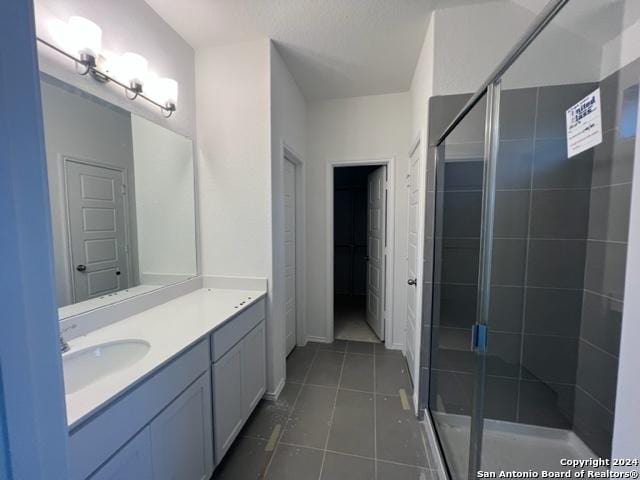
[{"left": 196, "top": 39, "right": 284, "bottom": 393}]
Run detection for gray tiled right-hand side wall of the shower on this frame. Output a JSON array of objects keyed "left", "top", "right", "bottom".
[{"left": 574, "top": 57, "right": 640, "bottom": 456}]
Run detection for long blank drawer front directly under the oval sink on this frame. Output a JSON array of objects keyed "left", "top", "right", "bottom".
[{"left": 69, "top": 339, "right": 209, "bottom": 480}]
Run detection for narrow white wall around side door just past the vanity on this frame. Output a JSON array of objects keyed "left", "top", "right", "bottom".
[{"left": 269, "top": 43, "right": 307, "bottom": 394}]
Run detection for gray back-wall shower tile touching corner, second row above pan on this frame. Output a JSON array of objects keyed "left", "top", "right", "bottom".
[{"left": 522, "top": 334, "right": 578, "bottom": 383}]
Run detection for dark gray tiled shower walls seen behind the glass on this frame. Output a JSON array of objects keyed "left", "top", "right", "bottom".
[{"left": 421, "top": 63, "right": 638, "bottom": 455}]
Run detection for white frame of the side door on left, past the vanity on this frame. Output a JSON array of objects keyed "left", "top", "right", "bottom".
[{"left": 280, "top": 140, "right": 307, "bottom": 348}]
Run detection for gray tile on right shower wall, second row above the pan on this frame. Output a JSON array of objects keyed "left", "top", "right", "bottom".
[{"left": 576, "top": 340, "right": 618, "bottom": 411}]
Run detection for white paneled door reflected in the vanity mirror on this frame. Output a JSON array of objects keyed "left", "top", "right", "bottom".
[{"left": 65, "top": 160, "right": 129, "bottom": 302}]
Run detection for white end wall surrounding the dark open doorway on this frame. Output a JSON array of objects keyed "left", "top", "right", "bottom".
[{"left": 306, "top": 93, "right": 412, "bottom": 348}]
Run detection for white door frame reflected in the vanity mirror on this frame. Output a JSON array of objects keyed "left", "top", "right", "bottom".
[{"left": 61, "top": 155, "right": 137, "bottom": 303}]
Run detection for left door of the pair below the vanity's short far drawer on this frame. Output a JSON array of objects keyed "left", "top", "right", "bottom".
[{"left": 213, "top": 341, "right": 245, "bottom": 463}]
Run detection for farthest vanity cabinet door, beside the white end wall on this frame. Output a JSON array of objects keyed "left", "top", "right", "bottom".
[{"left": 241, "top": 322, "right": 266, "bottom": 418}]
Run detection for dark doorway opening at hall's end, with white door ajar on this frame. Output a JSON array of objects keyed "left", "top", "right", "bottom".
[{"left": 333, "top": 165, "right": 388, "bottom": 343}]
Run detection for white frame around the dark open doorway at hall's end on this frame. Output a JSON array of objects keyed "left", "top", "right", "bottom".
[{"left": 325, "top": 157, "right": 395, "bottom": 345}]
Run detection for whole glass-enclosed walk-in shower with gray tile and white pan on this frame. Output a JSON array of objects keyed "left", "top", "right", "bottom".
[{"left": 421, "top": 0, "right": 640, "bottom": 479}]
